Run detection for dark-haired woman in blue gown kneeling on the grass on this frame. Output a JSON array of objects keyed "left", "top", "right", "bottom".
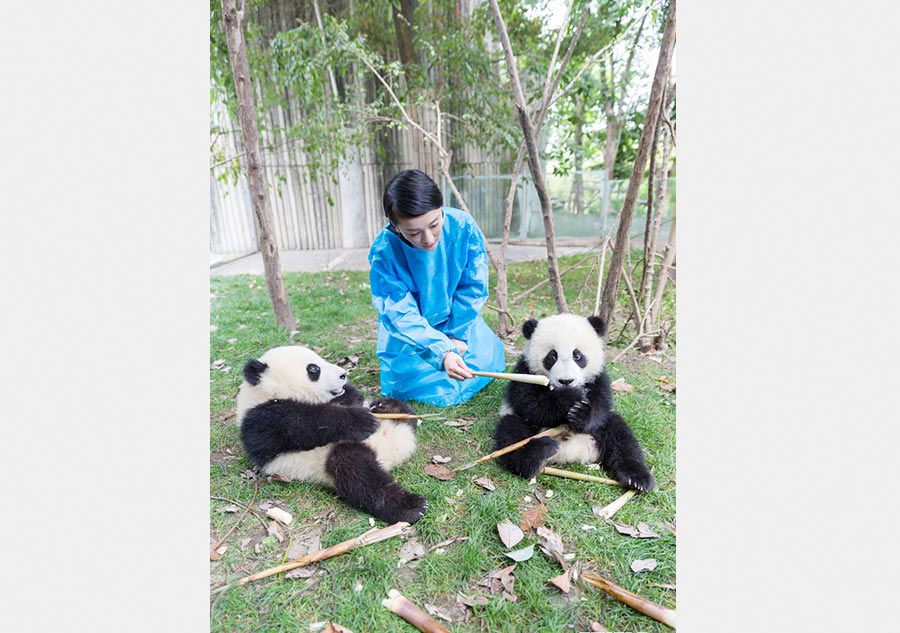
[{"left": 369, "top": 169, "right": 506, "bottom": 406}]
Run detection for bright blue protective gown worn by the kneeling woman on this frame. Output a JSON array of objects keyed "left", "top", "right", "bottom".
[{"left": 369, "top": 207, "right": 506, "bottom": 406}]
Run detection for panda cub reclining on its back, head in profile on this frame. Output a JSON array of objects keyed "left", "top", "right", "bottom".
[{"left": 236, "top": 345, "right": 428, "bottom": 523}]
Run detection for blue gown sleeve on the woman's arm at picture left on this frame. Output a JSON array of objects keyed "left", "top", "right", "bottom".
[{"left": 369, "top": 254, "right": 456, "bottom": 371}]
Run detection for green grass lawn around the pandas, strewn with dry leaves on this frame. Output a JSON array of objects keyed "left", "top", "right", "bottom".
[{"left": 210, "top": 255, "right": 675, "bottom": 633}]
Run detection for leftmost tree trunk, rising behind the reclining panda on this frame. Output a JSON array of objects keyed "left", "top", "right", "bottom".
[{"left": 222, "top": 0, "right": 297, "bottom": 331}]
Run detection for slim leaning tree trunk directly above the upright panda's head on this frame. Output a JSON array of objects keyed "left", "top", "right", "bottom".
[{"left": 490, "top": 0, "right": 569, "bottom": 312}]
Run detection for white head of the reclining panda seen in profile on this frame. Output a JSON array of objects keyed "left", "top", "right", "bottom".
[{"left": 236, "top": 345, "right": 347, "bottom": 421}]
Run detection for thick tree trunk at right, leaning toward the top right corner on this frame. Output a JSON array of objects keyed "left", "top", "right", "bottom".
[{"left": 600, "top": 0, "right": 676, "bottom": 323}]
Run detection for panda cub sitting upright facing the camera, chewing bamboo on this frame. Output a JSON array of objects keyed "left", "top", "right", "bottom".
[{"left": 494, "top": 314, "right": 655, "bottom": 491}]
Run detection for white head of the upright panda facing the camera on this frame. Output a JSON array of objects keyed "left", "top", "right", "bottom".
[{"left": 524, "top": 314, "right": 606, "bottom": 388}]
